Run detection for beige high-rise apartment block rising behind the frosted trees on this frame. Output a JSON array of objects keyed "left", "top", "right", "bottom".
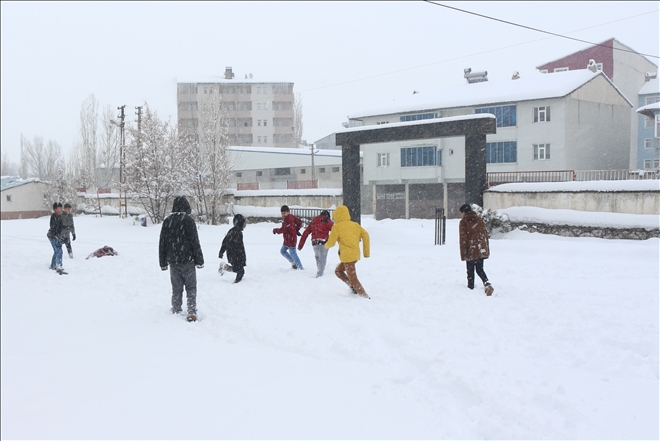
[{"left": 177, "top": 67, "right": 296, "bottom": 148}]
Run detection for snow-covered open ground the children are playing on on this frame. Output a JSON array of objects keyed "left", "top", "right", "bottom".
[{"left": 0, "top": 211, "right": 659, "bottom": 439}]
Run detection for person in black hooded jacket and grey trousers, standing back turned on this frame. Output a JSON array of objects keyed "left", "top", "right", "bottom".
[{"left": 158, "top": 196, "right": 204, "bottom": 322}]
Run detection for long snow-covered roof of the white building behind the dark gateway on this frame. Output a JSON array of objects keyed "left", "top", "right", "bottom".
[{"left": 348, "top": 69, "right": 632, "bottom": 119}]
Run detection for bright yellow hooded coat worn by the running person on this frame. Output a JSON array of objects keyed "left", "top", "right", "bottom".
[{"left": 325, "top": 205, "right": 369, "bottom": 263}]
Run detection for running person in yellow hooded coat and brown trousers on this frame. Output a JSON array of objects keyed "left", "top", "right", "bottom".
[{"left": 324, "top": 205, "right": 370, "bottom": 299}]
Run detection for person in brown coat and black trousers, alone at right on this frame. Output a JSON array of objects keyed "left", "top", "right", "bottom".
[{"left": 458, "top": 204, "right": 495, "bottom": 296}]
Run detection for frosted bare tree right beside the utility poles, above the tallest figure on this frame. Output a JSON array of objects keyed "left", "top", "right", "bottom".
[{"left": 125, "top": 103, "right": 185, "bottom": 223}]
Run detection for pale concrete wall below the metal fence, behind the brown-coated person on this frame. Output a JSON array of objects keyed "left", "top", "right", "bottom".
[{"left": 484, "top": 191, "right": 660, "bottom": 215}]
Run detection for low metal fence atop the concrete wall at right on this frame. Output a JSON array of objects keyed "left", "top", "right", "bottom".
[{"left": 486, "top": 169, "right": 660, "bottom": 188}]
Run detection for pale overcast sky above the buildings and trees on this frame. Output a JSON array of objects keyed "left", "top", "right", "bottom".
[{"left": 1, "top": 0, "right": 660, "bottom": 163}]
